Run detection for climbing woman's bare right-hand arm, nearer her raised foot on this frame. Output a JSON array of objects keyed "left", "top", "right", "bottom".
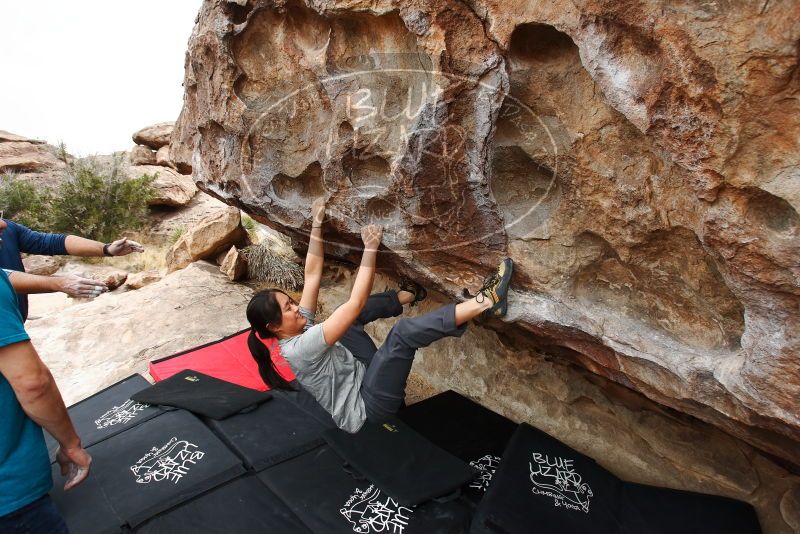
[{"left": 322, "top": 225, "right": 383, "bottom": 345}]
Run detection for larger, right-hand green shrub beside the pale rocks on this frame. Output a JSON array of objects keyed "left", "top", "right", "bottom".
[{"left": 49, "top": 159, "right": 155, "bottom": 241}]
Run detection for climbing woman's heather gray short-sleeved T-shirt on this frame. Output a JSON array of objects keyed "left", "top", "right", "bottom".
[{"left": 280, "top": 307, "right": 367, "bottom": 433}]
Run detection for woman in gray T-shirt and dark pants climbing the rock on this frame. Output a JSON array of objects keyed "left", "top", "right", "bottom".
[{"left": 247, "top": 199, "right": 512, "bottom": 433}]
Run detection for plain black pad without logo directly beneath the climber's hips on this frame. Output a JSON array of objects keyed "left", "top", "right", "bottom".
[{"left": 323, "top": 417, "right": 476, "bottom": 506}]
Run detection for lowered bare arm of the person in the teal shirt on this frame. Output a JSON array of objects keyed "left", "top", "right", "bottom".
[{"left": 0, "top": 341, "right": 92, "bottom": 489}]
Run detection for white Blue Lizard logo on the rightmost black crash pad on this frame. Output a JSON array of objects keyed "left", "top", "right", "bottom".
[{"left": 528, "top": 452, "right": 594, "bottom": 514}]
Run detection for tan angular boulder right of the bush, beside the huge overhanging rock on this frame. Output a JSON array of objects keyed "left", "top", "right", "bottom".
[{"left": 166, "top": 207, "right": 247, "bottom": 272}]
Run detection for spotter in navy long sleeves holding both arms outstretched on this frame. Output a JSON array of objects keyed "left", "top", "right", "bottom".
[{"left": 0, "top": 219, "right": 144, "bottom": 322}]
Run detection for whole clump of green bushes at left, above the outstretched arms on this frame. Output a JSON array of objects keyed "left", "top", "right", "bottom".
[{"left": 0, "top": 152, "right": 155, "bottom": 242}]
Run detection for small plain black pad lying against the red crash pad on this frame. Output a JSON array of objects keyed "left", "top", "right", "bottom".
[{"left": 131, "top": 369, "right": 272, "bottom": 419}]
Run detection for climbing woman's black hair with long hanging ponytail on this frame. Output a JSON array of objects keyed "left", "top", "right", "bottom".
[{"left": 247, "top": 289, "right": 294, "bottom": 389}]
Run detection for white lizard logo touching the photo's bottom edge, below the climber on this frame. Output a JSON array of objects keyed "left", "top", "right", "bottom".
[{"left": 339, "top": 485, "right": 413, "bottom": 534}]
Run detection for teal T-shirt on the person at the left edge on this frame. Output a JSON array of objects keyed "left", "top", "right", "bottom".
[{"left": 0, "top": 269, "right": 53, "bottom": 517}]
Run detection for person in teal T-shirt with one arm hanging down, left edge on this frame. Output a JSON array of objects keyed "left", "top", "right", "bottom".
[{"left": 0, "top": 219, "right": 92, "bottom": 534}]
